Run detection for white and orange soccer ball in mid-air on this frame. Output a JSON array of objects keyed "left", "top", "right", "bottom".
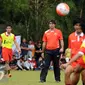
[{"left": 56, "top": 3, "right": 70, "bottom": 16}]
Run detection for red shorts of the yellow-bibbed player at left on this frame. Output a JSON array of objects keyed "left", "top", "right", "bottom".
[{"left": 2, "top": 48, "right": 12, "bottom": 61}]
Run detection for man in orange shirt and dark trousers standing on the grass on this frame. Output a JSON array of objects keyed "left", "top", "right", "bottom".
[{"left": 40, "top": 20, "right": 64, "bottom": 83}]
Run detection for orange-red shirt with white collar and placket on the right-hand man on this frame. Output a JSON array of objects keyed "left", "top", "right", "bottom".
[{"left": 68, "top": 32, "right": 85, "bottom": 57}]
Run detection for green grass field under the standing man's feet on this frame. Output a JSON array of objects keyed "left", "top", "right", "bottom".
[{"left": 0, "top": 71, "right": 82, "bottom": 85}]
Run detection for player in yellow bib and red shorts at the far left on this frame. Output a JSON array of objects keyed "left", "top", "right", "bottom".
[{"left": 0, "top": 25, "right": 21, "bottom": 77}]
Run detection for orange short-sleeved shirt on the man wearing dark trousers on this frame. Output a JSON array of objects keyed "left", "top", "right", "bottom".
[{"left": 43, "top": 29, "right": 63, "bottom": 50}]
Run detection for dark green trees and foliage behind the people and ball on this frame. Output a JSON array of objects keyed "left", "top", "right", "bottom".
[{"left": 0, "top": 0, "right": 85, "bottom": 47}]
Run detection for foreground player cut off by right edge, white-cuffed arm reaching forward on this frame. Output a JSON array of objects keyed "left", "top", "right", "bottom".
[{"left": 62, "top": 23, "right": 85, "bottom": 85}]
